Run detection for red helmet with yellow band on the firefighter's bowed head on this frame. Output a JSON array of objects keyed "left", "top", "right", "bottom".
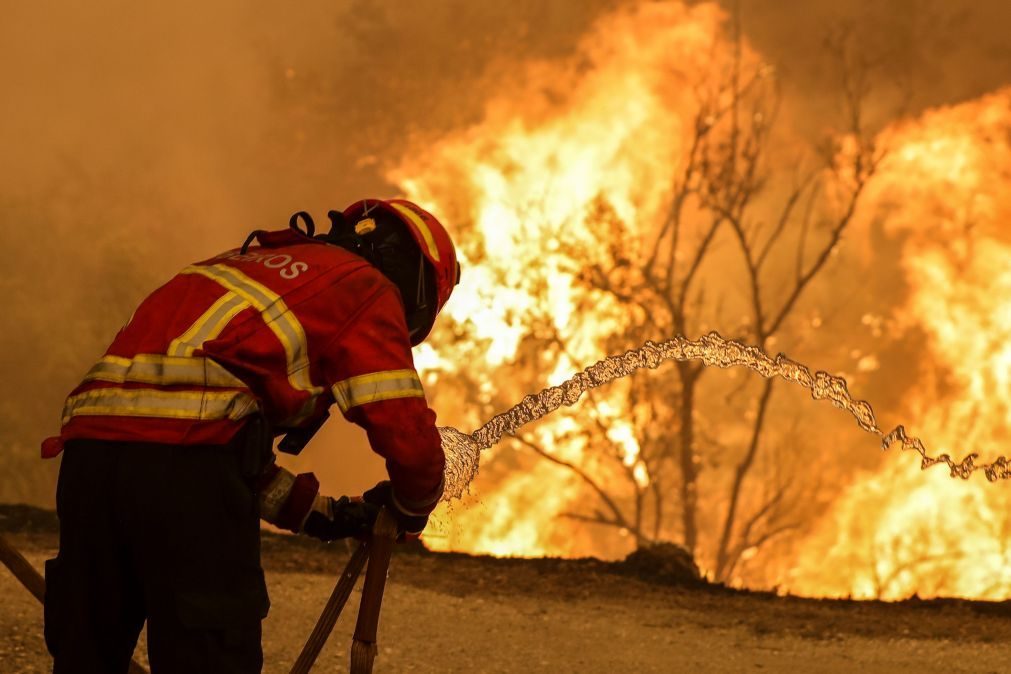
[{"left": 344, "top": 199, "right": 460, "bottom": 345}]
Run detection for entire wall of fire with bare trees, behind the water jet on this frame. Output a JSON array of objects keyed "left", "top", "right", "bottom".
[{"left": 391, "top": 3, "right": 1011, "bottom": 598}]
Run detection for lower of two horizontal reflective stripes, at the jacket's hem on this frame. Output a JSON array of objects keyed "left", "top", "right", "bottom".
[{"left": 63, "top": 388, "right": 257, "bottom": 423}]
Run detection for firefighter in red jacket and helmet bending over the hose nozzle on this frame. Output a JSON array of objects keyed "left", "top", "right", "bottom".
[{"left": 42, "top": 199, "right": 460, "bottom": 674}]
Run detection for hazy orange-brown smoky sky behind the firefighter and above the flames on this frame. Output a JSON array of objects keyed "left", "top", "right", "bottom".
[{"left": 0, "top": 0, "right": 1011, "bottom": 503}]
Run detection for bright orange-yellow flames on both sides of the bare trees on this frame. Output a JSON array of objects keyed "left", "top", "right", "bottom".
[{"left": 390, "top": 3, "right": 1011, "bottom": 598}]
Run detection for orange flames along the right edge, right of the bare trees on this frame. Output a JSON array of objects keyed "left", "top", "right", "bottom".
[{"left": 785, "top": 90, "right": 1011, "bottom": 599}]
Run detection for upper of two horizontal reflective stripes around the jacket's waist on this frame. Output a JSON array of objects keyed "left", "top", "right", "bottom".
[{"left": 84, "top": 354, "right": 246, "bottom": 387}]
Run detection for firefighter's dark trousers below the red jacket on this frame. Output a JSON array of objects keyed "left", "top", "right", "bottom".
[{"left": 45, "top": 435, "right": 269, "bottom": 674}]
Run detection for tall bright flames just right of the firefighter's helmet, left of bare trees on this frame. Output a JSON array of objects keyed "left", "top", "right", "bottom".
[{"left": 391, "top": 3, "right": 729, "bottom": 556}]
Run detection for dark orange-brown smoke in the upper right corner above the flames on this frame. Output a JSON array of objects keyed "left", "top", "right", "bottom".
[{"left": 721, "top": 0, "right": 1011, "bottom": 133}]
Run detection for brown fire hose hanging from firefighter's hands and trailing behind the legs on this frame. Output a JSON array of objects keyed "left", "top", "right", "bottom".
[{"left": 0, "top": 508, "right": 397, "bottom": 674}]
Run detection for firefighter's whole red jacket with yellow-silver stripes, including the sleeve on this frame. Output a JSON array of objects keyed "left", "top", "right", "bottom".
[{"left": 42, "top": 229, "right": 445, "bottom": 512}]
